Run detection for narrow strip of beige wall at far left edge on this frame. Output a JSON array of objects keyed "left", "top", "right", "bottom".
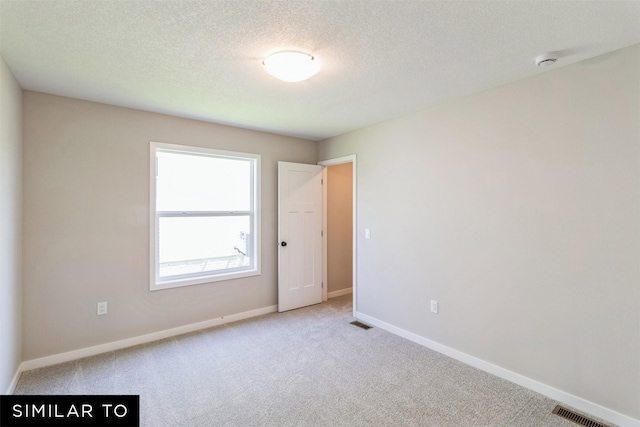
[{"left": 0, "top": 56, "right": 22, "bottom": 394}]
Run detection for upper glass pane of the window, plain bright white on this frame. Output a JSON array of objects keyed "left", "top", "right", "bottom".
[{"left": 156, "top": 150, "right": 253, "bottom": 211}]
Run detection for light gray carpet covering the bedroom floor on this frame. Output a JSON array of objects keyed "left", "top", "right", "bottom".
[{"left": 15, "top": 295, "right": 608, "bottom": 427}]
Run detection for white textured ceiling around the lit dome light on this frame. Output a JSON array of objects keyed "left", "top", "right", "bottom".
[{"left": 0, "top": 0, "right": 640, "bottom": 140}]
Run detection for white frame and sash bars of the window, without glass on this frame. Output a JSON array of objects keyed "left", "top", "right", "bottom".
[{"left": 149, "top": 141, "right": 260, "bottom": 291}]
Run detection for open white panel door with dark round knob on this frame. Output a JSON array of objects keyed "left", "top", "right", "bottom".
[{"left": 278, "top": 162, "right": 322, "bottom": 312}]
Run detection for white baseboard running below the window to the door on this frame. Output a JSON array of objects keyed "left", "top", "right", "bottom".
[{"left": 20, "top": 305, "right": 278, "bottom": 374}]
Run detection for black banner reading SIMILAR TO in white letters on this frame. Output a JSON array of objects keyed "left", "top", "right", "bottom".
[{"left": 0, "top": 395, "right": 140, "bottom": 427}]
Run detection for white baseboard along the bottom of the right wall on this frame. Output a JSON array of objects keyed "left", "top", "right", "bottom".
[{"left": 356, "top": 312, "right": 640, "bottom": 427}]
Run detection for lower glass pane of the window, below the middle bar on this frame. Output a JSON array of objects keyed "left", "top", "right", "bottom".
[{"left": 158, "top": 215, "right": 252, "bottom": 278}]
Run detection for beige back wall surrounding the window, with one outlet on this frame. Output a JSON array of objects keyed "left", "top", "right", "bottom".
[{"left": 23, "top": 92, "right": 316, "bottom": 360}]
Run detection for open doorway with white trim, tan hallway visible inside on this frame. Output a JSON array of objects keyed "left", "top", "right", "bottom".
[{"left": 318, "top": 155, "right": 357, "bottom": 317}]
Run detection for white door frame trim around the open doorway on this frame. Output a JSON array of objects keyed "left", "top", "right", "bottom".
[{"left": 318, "top": 154, "right": 358, "bottom": 317}]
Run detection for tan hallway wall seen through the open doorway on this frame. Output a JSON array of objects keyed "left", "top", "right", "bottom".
[{"left": 327, "top": 163, "right": 353, "bottom": 292}]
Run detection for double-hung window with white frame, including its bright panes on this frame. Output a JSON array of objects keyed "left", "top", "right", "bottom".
[{"left": 150, "top": 142, "right": 260, "bottom": 290}]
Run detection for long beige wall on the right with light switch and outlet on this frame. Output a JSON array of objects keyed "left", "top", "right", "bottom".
[{"left": 319, "top": 45, "right": 640, "bottom": 420}]
